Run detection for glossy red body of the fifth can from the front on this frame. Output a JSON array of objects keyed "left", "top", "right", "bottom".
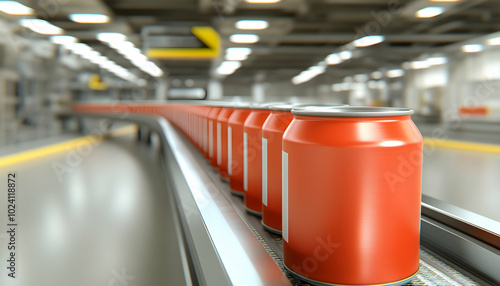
[{"left": 217, "top": 107, "right": 234, "bottom": 179}]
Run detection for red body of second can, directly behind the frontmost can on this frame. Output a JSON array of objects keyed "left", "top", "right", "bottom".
[{"left": 262, "top": 110, "right": 293, "bottom": 233}]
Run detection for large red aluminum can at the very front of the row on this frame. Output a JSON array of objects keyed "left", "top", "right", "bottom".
[{"left": 282, "top": 106, "right": 422, "bottom": 285}]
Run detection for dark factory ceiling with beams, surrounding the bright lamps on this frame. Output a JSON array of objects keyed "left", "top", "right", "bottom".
[{"left": 11, "top": 0, "right": 500, "bottom": 81}]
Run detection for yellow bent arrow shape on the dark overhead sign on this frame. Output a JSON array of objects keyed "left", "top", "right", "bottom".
[{"left": 147, "top": 26, "right": 220, "bottom": 60}]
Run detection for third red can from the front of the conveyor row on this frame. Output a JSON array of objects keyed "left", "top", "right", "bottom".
[{"left": 243, "top": 105, "right": 271, "bottom": 216}]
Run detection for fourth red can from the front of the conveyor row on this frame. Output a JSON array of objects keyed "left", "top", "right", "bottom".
[{"left": 228, "top": 105, "right": 252, "bottom": 196}]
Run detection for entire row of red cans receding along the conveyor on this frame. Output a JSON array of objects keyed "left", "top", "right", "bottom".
[{"left": 71, "top": 102, "right": 422, "bottom": 285}]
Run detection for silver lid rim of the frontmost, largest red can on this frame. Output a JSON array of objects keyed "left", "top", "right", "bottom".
[{"left": 292, "top": 106, "right": 414, "bottom": 117}]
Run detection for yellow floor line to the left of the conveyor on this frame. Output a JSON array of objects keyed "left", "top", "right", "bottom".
[{"left": 0, "top": 126, "right": 137, "bottom": 168}]
